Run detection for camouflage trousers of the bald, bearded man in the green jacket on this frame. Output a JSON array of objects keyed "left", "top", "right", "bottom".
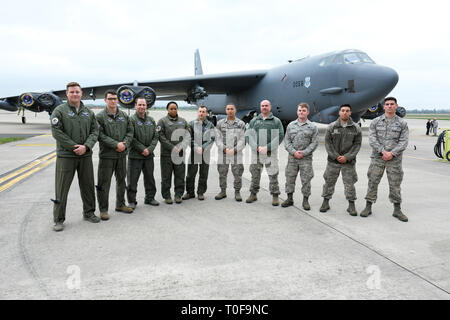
[{"left": 250, "top": 156, "right": 280, "bottom": 195}]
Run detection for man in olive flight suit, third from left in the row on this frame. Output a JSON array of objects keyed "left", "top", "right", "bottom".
[{"left": 127, "top": 97, "right": 159, "bottom": 209}]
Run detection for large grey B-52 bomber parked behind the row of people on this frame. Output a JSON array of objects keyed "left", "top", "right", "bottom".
[{"left": 0, "top": 49, "right": 398, "bottom": 126}]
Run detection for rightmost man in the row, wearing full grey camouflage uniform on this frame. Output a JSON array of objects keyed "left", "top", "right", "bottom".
[{"left": 360, "top": 97, "right": 409, "bottom": 222}]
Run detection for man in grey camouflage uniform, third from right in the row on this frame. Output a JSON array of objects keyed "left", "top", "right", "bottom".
[{"left": 281, "top": 102, "right": 318, "bottom": 210}]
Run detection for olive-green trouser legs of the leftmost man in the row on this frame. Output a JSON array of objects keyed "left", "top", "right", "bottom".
[{"left": 53, "top": 156, "right": 95, "bottom": 223}]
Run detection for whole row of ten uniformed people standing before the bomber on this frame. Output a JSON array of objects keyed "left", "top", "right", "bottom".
[{"left": 51, "top": 82, "right": 408, "bottom": 231}]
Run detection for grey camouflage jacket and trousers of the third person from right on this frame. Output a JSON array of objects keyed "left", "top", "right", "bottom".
[{"left": 284, "top": 120, "right": 319, "bottom": 197}]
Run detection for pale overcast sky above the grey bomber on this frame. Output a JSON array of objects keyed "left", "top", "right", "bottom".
[{"left": 0, "top": 0, "right": 450, "bottom": 109}]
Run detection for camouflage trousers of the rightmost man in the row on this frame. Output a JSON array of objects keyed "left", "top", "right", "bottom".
[{"left": 366, "top": 158, "right": 403, "bottom": 203}]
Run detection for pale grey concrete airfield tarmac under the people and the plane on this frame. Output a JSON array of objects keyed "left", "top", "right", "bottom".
[{"left": 0, "top": 110, "right": 450, "bottom": 300}]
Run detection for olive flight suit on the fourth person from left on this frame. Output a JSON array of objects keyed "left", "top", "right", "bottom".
[{"left": 157, "top": 115, "right": 191, "bottom": 199}]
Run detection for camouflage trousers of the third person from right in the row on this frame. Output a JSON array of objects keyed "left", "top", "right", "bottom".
[{"left": 286, "top": 156, "right": 314, "bottom": 197}]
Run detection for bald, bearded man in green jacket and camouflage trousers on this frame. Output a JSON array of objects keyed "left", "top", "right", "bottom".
[{"left": 246, "top": 100, "right": 284, "bottom": 206}]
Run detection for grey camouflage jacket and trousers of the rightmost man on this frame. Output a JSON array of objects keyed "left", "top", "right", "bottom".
[{"left": 366, "top": 115, "right": 409, "bottom": 204}]
